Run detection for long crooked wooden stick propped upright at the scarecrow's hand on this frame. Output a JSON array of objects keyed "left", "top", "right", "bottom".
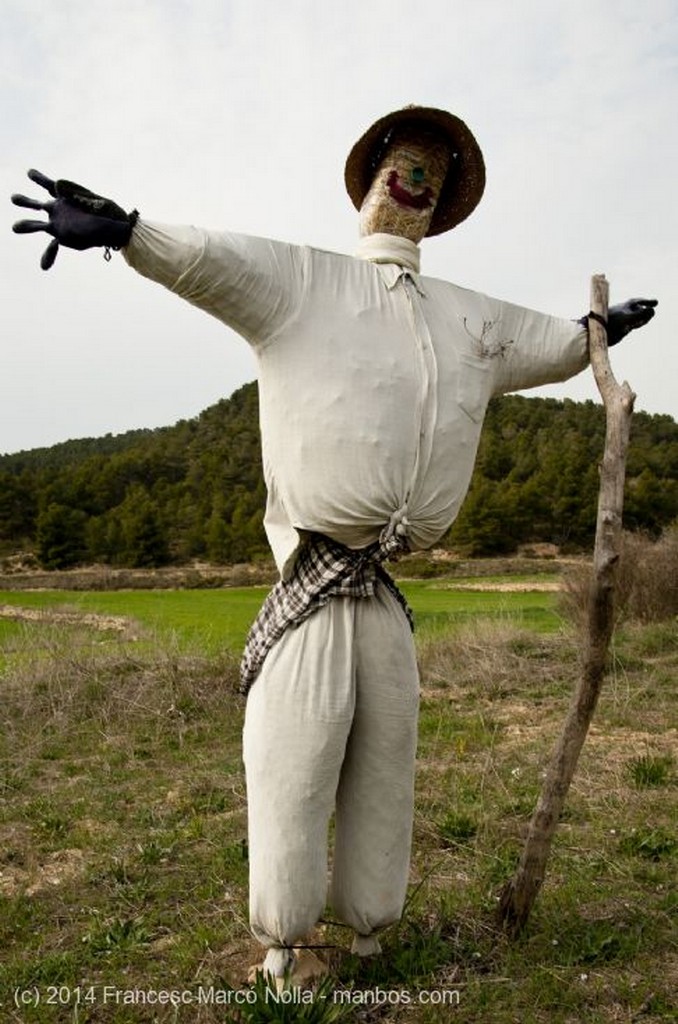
[{"left": 498, "top": 274, "right": 635, "bottom": 936}]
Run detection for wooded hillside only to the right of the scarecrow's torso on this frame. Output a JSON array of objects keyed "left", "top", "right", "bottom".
[{"left": 448, "top": 395, "right": 678, "bottom": 555}]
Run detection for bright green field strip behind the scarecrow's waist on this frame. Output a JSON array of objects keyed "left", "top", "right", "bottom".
[{"left": 0, "top": 577, "right": 559, "bottom": 651}]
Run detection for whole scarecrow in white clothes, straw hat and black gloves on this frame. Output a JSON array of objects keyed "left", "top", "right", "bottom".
[{"left": 12, "top": 106, "right": 656, "bottom": 980}]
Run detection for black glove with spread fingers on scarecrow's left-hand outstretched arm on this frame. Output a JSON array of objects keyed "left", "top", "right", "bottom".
[{"left": 11, "top": 171, "right": 138, "bottom": 270}]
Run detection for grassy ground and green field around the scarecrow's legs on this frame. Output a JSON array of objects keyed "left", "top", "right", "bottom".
[{"left": 0, "top": 581, "right": 678, "bottom": 1024}]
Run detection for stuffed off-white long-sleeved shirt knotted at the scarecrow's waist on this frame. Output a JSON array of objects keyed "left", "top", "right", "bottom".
[{"left": 125, "top": 220, "right": 588, "bottom": 579}]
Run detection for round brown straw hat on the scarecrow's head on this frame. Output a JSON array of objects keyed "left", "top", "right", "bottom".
[{"left": 344, "top": 103, "right": 485, "bottom": 234}]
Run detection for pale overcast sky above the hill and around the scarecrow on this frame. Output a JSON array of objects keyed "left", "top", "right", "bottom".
[{"left": 0, "top": 0, "right": 678, "bottom": 453}]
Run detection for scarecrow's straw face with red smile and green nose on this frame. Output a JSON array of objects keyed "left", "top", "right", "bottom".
[{"left": 361, "top": 126, "right": 450, "bottom": 244}]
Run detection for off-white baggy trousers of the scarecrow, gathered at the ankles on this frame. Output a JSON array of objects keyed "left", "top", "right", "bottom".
[{"left": 244, "top": 583, "right": 419, "bottom": 974}]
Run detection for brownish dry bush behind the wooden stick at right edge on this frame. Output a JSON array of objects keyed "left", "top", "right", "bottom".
[{"left": 560, "top": 524, "right": 678, "bottom": 627}]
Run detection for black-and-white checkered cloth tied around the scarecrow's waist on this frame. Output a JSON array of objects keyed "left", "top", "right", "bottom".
[{"left": 240, "top": 534, "right": 414, "bottom": 694}]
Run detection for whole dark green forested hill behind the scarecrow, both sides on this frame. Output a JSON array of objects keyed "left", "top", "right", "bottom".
[{"left": 0, "top": 384, "right": 678, "bottom": 568}]
